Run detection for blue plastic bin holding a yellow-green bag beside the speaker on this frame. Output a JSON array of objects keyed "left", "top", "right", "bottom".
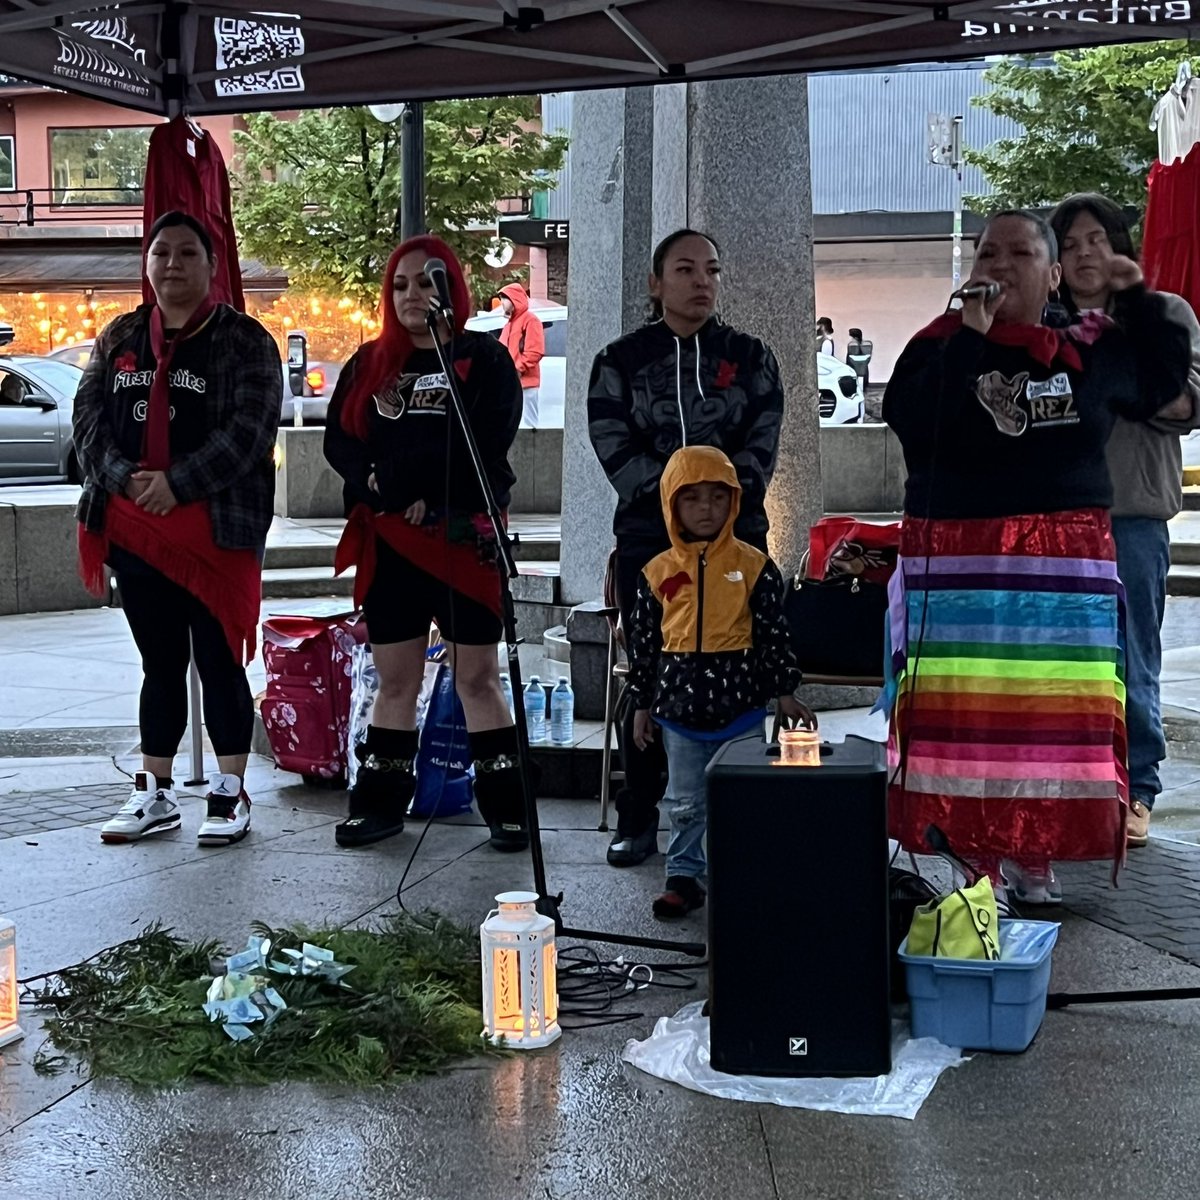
[{"left": 900, "top": 920, "right": 1058, "bottom": 1051}]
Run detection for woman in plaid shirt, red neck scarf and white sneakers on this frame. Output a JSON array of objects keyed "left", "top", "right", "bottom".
[{"left": 74, "top": 212, "right": 282, "bottom": 845}]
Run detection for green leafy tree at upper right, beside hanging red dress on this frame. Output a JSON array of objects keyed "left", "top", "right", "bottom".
[{"left": 965, "top": 42, "right": 1188, "bottom": 212}]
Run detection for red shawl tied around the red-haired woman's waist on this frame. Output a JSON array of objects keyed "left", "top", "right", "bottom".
[{"left": 334, "top": 504, "right": 500, "bottom": 632}]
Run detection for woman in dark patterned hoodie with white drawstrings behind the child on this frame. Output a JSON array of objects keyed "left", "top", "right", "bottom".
[{"left": 588, "top": 229, "right": 784, "bottom": 866}]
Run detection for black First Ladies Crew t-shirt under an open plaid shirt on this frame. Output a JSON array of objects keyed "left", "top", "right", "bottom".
[{"left": 106, "top": 322, "right": 212, "bottom": 463}]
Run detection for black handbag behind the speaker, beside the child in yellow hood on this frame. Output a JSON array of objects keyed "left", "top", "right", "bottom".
[{"left": 784, "top": 575, "right": 888, "bottom": 677}]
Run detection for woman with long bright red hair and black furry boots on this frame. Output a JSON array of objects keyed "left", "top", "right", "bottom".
[{"left": 325, "top": 236, "right": 529, "bottom": 850}]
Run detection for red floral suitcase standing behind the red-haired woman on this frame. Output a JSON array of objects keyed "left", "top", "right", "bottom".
[{"left": 255, "top": 613, "right": 366, "bottom": 787}]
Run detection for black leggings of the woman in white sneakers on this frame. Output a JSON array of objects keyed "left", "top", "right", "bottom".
[{"left": 116, "top": 563, "right": 254, "bottom": 758}]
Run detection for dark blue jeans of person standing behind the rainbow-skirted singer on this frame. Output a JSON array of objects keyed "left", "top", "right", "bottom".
[{"left": 1112, "top": 517, "right": 1171, "bottom": 809}]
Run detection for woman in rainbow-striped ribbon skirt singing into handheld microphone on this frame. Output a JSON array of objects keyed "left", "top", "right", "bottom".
[{"left": 883, "top": 212, "right": 1190, "bottom": 905}]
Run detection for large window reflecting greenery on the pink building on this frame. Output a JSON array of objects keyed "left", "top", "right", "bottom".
[{"left": 50, "top": 125, "right": 151, "bottom": 205}]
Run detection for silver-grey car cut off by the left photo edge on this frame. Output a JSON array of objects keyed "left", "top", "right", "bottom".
[{"left": 0, "top": 354, "right": 83, "bottom": 484}]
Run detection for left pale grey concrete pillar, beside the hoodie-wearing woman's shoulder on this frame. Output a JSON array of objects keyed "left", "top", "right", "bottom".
[{"left": 562, "top": 88, "right": 652, "bottom": 604}]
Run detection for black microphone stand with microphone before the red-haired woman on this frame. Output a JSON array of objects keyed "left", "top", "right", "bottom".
[{"left": 425, "top": 304, "right": 707, "bottom": 958}]
